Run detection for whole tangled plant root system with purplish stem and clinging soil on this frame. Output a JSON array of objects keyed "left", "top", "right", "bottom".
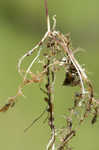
[{"left": 0, "top": 0, "right": 99, "bottom": 150}]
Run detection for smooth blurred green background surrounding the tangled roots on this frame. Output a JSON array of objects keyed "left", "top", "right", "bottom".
[{"left": 0, "top": 0, "right": 99, "bottom": 150}]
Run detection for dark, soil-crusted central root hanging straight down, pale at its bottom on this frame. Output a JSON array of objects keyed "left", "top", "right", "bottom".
[{"left": 45, "top": 57, "right": 55, "bottom": 150}]
